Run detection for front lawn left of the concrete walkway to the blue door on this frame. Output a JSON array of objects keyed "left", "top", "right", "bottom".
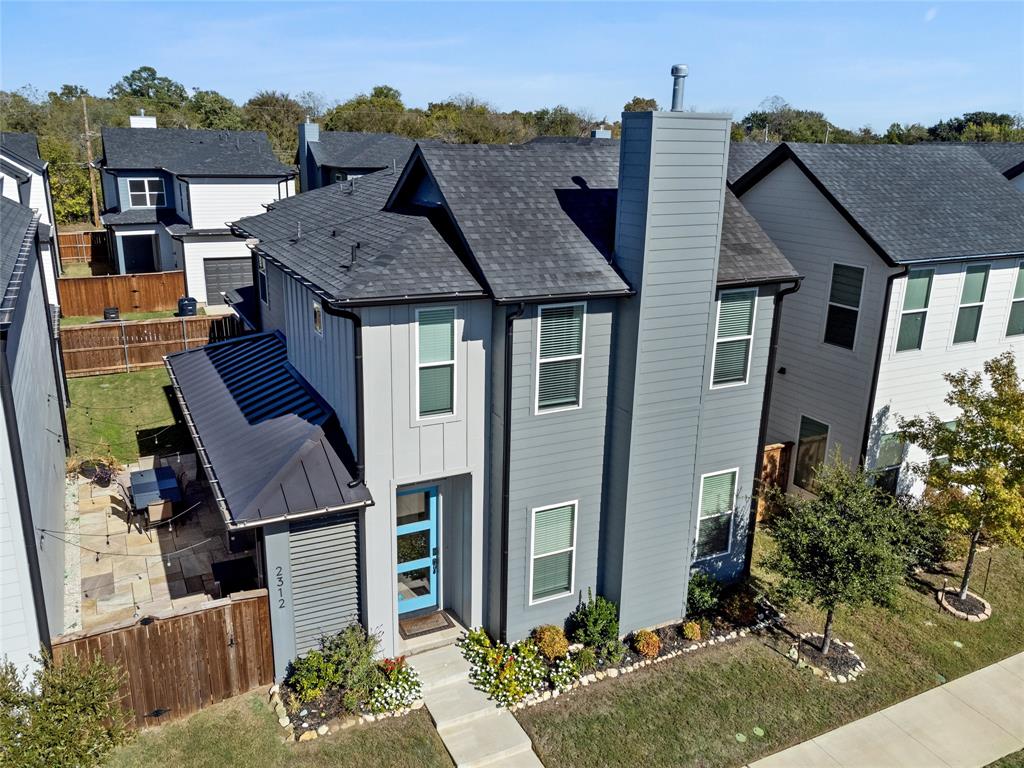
[{"left": 109, "top": 694, "right": 452, "bottom": 768}]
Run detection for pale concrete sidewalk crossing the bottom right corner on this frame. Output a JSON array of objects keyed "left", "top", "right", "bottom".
[{"left": 750, "top": 653, "right": 1024, "bottom": 768}]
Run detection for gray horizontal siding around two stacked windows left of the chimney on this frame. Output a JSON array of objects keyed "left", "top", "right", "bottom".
[{"left": 495, "top": 299, "right": 615, "bottom": 642}]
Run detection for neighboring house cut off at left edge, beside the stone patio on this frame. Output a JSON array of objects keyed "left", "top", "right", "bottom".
[{"left": 0, "top": 197, "right": 68, "bottom": 668}]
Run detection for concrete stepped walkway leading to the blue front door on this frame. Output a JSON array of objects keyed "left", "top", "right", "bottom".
[{"left": 409, "top": 645, "right": 544, "bottom": 768}]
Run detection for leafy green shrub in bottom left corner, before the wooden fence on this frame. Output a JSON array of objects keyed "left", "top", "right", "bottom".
[{"left": 0, "top": 656, "right": 132, "bottom": 768}]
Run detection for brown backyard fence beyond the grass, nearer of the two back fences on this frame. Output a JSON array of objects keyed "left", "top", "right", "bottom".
[{"left": 60, "top": 314, "right": 243, "bottom": 377}]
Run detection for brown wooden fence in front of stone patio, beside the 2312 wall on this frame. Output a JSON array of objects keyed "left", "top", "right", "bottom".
[{"left": 53, "top": 590, "right": 273, "bottom": 726}]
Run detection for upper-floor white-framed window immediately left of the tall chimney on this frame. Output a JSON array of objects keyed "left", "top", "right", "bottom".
[{"left": 537, "top": 304, "right": 585, "bottom": 412}]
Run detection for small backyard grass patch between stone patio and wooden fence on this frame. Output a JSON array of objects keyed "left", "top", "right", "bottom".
[{"left": 68, "top": 368, "right": 193, "bottom": 463}]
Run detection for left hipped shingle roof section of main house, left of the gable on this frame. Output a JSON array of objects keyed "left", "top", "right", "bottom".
[{"left": 234, "top": 171, "right": 482, "bottom": 301}]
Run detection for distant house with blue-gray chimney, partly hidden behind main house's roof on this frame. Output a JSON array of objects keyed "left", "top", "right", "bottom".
[{"left": 295, "top": 122, "right": 416, "bottom": 191}]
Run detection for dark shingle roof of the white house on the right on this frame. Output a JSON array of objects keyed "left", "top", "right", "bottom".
[{"left": 735, "top": 142, "right": 1024, "bottom": 263}]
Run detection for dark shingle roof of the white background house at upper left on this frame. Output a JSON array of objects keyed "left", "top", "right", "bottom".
[{"left": 102, "top": 128, "right": 294, "bottom": 176}]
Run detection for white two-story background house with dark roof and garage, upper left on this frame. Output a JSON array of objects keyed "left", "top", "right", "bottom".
[{"left": 97, "top": 118, "right": 295, "bottom": 305}]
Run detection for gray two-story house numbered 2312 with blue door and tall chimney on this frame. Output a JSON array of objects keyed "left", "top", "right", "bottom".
[{"left": 168, "top": 103, "right": 799, "bottom": 674}]
